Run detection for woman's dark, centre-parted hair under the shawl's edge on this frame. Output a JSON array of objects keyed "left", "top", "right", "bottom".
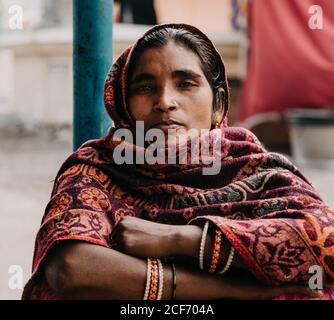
[{"left": 128, "top": 27, "right": 228, "bottom": 126}]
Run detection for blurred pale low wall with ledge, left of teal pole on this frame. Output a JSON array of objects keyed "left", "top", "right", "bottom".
[{"left": 0, "top": 29, "right": 73, "bottom": 129}]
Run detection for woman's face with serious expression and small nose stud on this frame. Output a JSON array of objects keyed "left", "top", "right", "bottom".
[{"left": 127, "top": 42, "right": 213, "bottom": 142}]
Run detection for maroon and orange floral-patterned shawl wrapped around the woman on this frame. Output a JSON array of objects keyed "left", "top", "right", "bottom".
[{"left": 23, "top": 25, "right": 334, "bottom": 299}]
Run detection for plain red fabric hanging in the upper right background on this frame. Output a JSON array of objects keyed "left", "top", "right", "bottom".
[{"left": 239, "top": 0, "right": 334, "bottom": 125}]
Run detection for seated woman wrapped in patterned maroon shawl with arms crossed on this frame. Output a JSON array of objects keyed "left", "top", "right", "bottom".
[{"left": 23, "top": 24, "right": 334, "bottom": 300}]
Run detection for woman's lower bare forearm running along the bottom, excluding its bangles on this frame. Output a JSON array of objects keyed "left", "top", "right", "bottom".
[{"left": 45, "top": 242, "right": 319, "bottom": 300}]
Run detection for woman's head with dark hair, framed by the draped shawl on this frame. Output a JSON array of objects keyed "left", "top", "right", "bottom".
[{"left": 105, "top": 24, "right": 229, "bottom": 131}]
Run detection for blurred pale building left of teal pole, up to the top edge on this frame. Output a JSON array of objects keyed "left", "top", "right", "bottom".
[{"left": 0, "top": 0, "right": 72, "bottom": 131}]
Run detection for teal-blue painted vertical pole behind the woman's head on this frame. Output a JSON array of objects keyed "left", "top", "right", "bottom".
[{"left": 73, "top": 0, "right": 113, "bottom": 150}]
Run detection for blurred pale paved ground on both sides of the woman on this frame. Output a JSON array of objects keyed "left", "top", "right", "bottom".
[{"left": 0, "top": 136, "right": 334, "bottom": 299}]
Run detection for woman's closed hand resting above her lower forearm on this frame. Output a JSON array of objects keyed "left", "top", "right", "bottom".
[{"left": 111, "top": 216, "right": 183, "bottom": 258}]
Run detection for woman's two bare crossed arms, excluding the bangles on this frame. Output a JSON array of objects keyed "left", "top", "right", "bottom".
[{"left": 44, "top": 217, "right": 319, "bottom": 300}]
